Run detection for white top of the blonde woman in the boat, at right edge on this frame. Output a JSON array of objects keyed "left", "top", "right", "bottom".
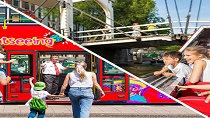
[{"left": 200, "top": 59, "right": 210, "bottom": 82}]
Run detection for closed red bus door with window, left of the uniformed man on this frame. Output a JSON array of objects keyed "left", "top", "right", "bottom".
[{"left": 6, "top": 52, "right": 37, "bottom": 102}]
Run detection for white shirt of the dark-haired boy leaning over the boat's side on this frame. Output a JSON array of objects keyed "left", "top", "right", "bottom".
[{"left": 168, "top": 63, "right": 192, "bottom": 81}]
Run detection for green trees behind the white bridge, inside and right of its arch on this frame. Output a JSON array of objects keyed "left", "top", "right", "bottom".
[{"left": 74, "top": 0, "right": 164, "bottom": 29}]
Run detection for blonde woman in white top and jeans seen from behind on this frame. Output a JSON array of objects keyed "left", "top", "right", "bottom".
[{"left": 60, "top": 62, "right": 105, "bottom": 118}]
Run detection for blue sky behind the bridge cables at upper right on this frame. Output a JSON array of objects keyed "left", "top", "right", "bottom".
[{"left": 154, "top": 0, "right": 210, "bottom": 33}]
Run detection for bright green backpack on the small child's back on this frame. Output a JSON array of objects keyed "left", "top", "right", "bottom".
[{"left": 29, "top": 97, "right": 47, "bottom": 111}]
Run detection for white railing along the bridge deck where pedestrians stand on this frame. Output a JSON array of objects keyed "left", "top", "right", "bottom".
[{"left": 74, "top": 21, "right": 210, "bottom": 41}]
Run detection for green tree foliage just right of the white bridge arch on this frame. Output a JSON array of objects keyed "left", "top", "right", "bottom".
[{"left": 113, "top": 0, "right": 156, "bottom": 25}]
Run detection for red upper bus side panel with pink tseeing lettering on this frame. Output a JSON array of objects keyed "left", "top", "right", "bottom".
[{"left": 0, "top": 24, "right": 83, "bottom": 51}]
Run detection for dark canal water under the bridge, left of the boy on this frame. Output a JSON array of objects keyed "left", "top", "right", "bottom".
[{"left": 120, "top": 62, "right": 164, "bottom": 77}]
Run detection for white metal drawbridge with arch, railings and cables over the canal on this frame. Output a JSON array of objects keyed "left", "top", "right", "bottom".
[{"left": 10, "top": 0, "right": 209, "bottom": 48}]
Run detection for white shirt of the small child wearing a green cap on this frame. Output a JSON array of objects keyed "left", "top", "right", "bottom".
[{"left": 25, "top": 88, "right": 50, "bottom": 106}]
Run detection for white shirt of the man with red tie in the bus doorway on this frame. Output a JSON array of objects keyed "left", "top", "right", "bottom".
[{"left": 42, "top": 61, "right": 65, "bottom": 75}]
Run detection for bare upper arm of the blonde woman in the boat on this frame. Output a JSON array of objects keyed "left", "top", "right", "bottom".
[{"left": 189, "top": 60, "right": 206, "bottom": 83}]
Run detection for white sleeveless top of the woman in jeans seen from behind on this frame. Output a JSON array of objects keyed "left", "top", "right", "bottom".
[{"left": 69, "top": 71, "right": 93, "bottom": 87}]
